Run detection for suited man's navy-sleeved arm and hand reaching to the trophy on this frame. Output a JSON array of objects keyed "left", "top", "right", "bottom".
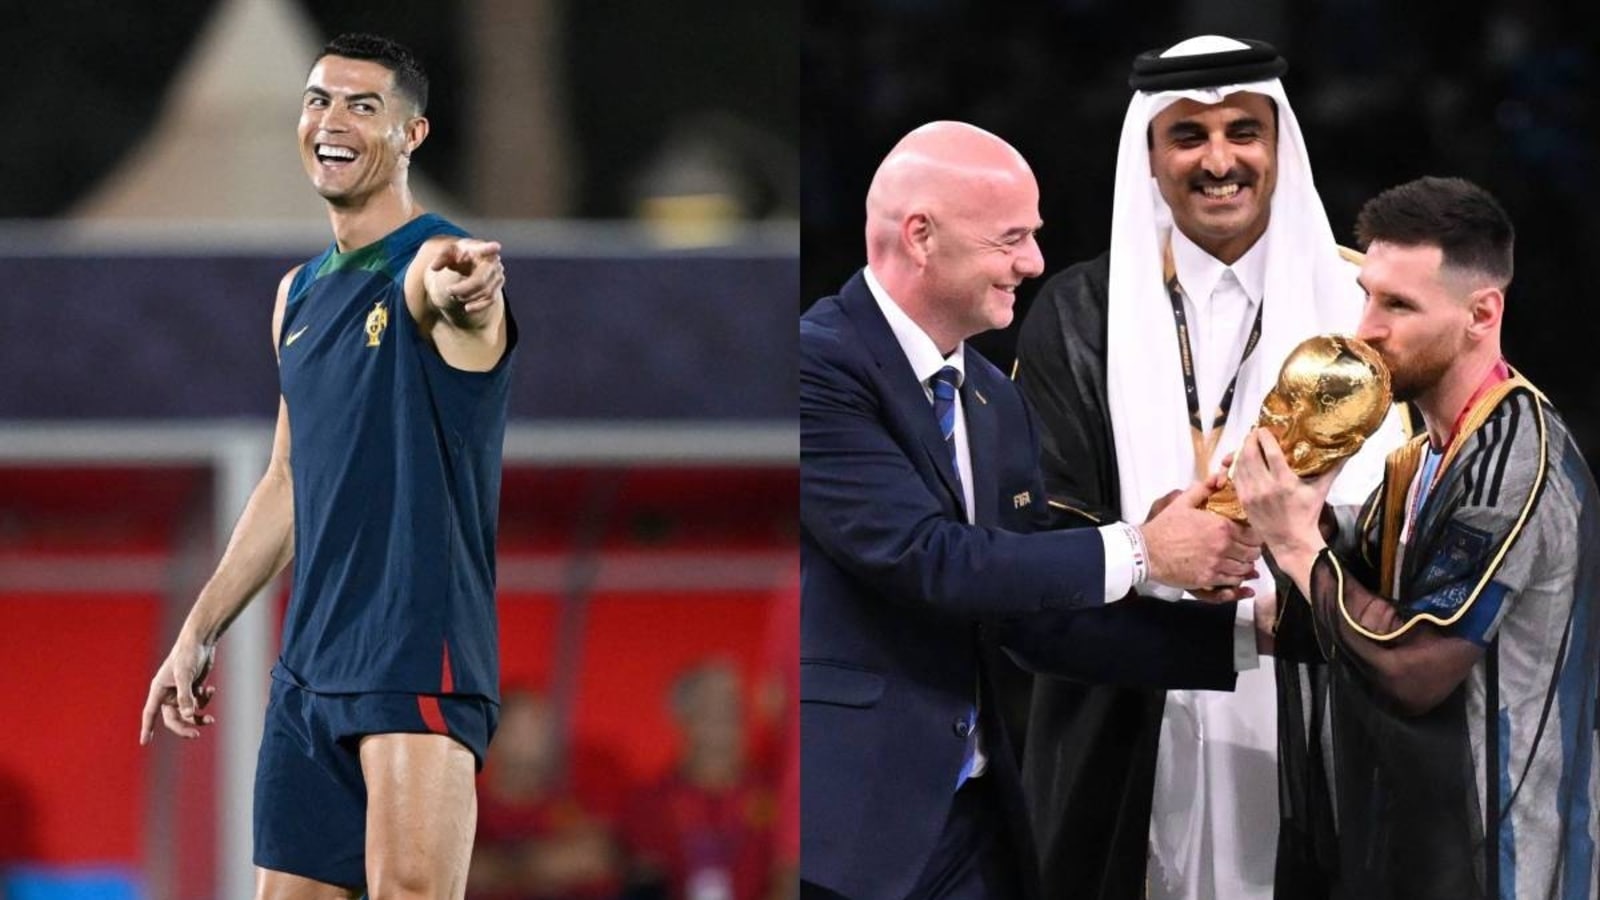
[{"left": 800, "top": 320, "right": 1256, "bottom": 615}]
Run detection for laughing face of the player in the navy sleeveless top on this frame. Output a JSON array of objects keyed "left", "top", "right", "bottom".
[{"left": 298, "top": 56, "right": 427, "bottom": 207}]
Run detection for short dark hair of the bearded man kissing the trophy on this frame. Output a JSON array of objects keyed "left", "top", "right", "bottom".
[{"left": 1355, "top": 176, "right": 1517, "bottom": 285}]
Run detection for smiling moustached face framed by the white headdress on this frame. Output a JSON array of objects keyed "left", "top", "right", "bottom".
[{"left": 1150, "top": 91, "right": 1278, "bottom": 263}]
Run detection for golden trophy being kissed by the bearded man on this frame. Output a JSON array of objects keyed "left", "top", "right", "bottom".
[{"left": 1205, "top": 335, "right": 1394, "bottom": 522}]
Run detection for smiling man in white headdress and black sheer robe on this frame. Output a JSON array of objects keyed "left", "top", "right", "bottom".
[{"left": 1016, "top": 35, "right": 1403, "bottom": 900}]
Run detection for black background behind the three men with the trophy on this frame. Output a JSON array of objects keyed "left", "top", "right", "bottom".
[{"left": 800, "top": 0, "right": 1600, "bottom": 463}]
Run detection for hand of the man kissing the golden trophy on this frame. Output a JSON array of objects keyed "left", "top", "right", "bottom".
[{"left": 1234, "top": 428, "right": 1344, "bottom": 556}]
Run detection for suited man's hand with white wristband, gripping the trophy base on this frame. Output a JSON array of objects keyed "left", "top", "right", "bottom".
[{"left": 1139, "top": 479, "right": 1261, "bottom": 601}]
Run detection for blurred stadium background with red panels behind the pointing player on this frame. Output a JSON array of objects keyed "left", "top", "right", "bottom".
[{"left": 0, "top": 0, "right": 798, "bottom": 898}]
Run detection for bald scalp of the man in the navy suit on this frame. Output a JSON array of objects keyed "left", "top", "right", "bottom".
[{"left": 867, "top": 122, "right": 1037, "bottom": 264}]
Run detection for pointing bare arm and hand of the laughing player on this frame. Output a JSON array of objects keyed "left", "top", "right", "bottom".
[{"left": 405, "top": 237, "right": 506, "bottom": 372}]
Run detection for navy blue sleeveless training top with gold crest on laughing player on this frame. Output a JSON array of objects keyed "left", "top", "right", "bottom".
[{"left": 272, "top": 215, "right": 517, "bottom": 701}]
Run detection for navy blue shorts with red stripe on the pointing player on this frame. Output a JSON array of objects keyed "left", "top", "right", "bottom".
[{"left": 254, "top": 679, "right": 499, "bottom": 887}]
